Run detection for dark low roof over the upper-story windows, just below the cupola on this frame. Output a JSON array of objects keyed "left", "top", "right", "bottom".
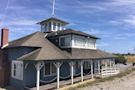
[{"left": 47, "top": 29, "right": 99, "bottom": 39}]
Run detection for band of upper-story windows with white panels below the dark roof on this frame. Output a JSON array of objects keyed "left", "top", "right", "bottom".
[{"left": 59, "top": 35, "right": 96, "bottom": 49}]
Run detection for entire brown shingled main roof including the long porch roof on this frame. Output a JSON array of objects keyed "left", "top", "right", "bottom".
[{"left": 6, "top": 32, "right": 115, "bottom": 61}]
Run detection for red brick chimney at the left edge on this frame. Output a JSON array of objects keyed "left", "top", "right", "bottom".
[{"left": 1, "top": 28, "right": 9, "bottom": 48}]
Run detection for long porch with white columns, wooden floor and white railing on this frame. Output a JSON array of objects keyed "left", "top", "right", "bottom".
[{"left": 22, "top": 59, "right": 118, "bottom": 90}]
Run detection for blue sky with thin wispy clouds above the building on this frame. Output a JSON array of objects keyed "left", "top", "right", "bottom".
[{"left": 0, "top": 0, "right": 135, "bottom": 53}]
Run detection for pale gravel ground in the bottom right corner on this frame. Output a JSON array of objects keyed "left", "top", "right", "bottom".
[{"left": 78, "top": 72, "right": 135, "bottom": 90}]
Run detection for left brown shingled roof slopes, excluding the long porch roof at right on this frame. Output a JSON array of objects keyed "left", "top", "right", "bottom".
[{"left": 7, "top": 32, "right": 69, "bottom": 60}]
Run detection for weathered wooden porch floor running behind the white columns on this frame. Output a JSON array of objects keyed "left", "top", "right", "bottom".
[{"left": 30, "top": 75, "right": 91, "bottom": 90}]
